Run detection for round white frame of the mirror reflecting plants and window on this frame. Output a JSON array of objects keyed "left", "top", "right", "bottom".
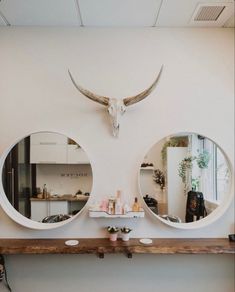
[{"left": 138, "top": 132, "right": 234, "bottom": 230}]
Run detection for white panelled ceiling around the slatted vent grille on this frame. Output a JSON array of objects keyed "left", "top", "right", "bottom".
[{"left": 0, "top": 0, "right": 234, "bottom": 27}]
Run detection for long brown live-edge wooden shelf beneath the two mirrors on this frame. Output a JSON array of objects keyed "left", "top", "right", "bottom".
[{"left": 0, "top": 238, "right": 235, "bottom": 258}]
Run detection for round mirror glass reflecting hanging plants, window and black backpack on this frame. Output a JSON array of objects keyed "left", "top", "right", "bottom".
[{"left": 140, "top": 133, "right": 230, "bottom": 223}]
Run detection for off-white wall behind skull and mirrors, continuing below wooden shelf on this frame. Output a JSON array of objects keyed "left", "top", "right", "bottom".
[{"left": 0, "top": 27, "right": 234, "bottom": 292}]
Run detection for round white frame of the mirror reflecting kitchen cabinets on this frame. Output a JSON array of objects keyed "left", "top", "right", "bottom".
[{"left": 0, "top": 130, "right": 93, "bottom": 230}]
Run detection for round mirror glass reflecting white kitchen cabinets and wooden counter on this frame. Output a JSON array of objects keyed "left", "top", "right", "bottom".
[{"left": 2, "top": 132, "right": 92, "bottom": 223}]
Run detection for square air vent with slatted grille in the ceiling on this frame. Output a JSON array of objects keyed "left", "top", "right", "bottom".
[{"left": 190, "top": 2, "right": 234, "bottom": 27}]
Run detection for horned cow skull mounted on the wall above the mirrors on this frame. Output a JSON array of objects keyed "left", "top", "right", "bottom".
[{"left": 68, "top": 66, "right": 163, "bottom": 137}]
